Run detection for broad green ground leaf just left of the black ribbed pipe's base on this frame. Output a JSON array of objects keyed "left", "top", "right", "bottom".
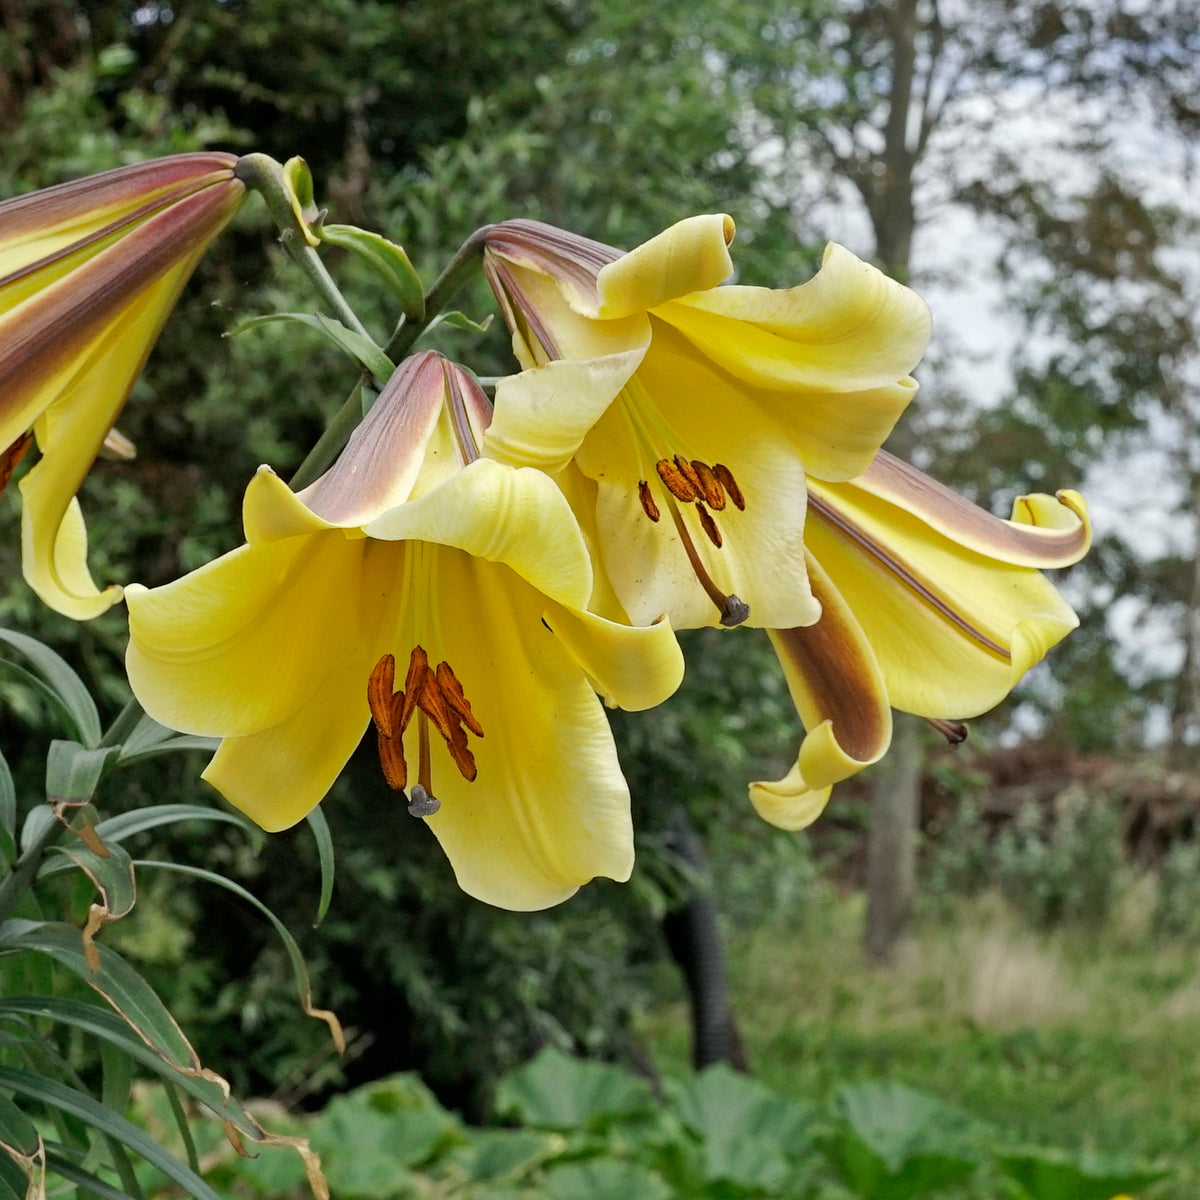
[{"left": 496, "top": 1046, "right": 655, "bottom": 1132}]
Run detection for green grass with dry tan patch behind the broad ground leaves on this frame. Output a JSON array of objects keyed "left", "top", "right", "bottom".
[{"left": 646, "top": 884, "right": 1200, "bottom": 1200}]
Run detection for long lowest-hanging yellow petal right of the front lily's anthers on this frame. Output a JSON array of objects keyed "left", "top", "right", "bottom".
[{"left": 408, "top": 548, "right": 634, "bottom": 911}]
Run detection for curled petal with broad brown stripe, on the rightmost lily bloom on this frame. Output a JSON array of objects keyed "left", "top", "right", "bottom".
[{"left": 750, "top": 558, "right": 892, "bottom": 829}]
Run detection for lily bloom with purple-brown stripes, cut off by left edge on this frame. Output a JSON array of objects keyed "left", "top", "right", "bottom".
[{"left": 0, "top": 154, "right": 245, "bottom": 620}]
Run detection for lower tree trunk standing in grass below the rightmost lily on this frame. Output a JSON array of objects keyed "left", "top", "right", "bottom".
[{"left": 863, "top": 713, "right": 924, "bottom": 964}]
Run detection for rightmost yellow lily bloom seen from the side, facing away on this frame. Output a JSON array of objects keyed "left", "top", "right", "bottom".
[{"left": 750, "top": 452, "right": 1091, "bottom": 829}]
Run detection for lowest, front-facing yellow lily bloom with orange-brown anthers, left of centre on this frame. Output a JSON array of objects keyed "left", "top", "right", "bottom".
[{"left": 126, "top": 353, "right": 683, "bottom": 910}]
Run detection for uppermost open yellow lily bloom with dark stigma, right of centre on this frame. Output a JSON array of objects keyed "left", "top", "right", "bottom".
[{"left": 481, "top": 215, "right": 929, "bottom": 629}]
